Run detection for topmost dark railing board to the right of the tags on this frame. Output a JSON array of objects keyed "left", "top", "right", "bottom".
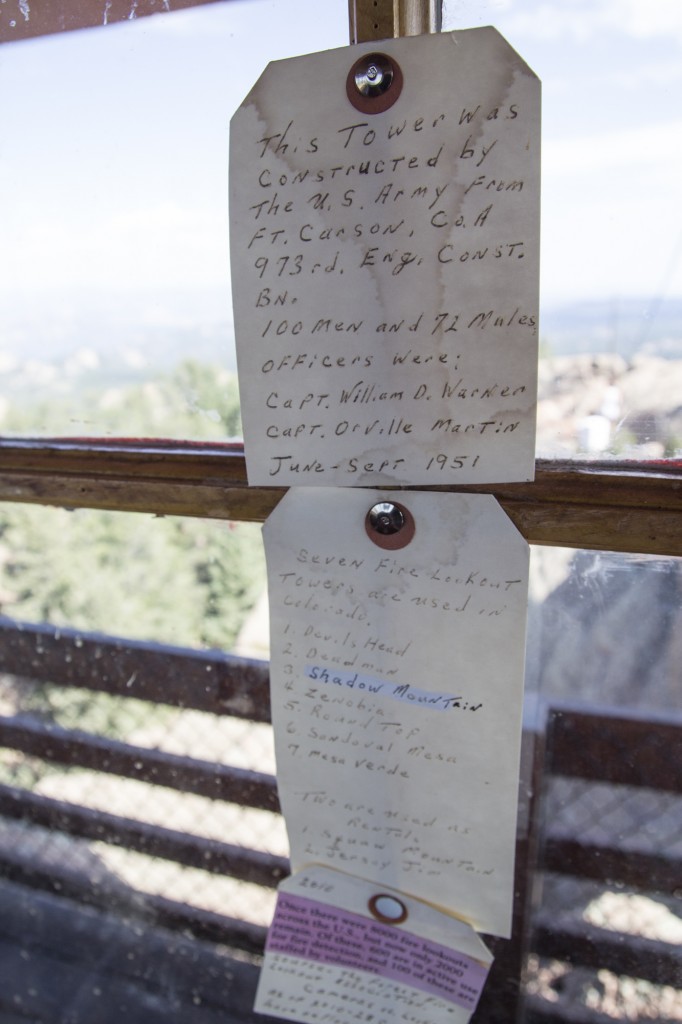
[{"left": 547, "top": 708, "right": 682, "bottom": 794}]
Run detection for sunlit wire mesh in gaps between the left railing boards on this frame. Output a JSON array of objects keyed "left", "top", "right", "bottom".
[{"left": 0, "top": 676, "right": 288, "bottom": 925}]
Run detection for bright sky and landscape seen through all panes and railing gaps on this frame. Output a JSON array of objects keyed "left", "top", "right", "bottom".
[{"left": 0, "top": 9, "right": 682, "bottom": 1020}]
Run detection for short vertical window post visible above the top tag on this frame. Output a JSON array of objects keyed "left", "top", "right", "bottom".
[{"left": 348, "top": 0, "right": 442, "bottom": 43}]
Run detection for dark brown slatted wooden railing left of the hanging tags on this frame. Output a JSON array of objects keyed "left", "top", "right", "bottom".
[{"left": 0, "top": 620, "right": 288, "bottom": 966}]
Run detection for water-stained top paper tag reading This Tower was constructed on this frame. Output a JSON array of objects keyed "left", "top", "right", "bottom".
[{"left": 229, "top": 28, "right": 540, "bottom": 486}]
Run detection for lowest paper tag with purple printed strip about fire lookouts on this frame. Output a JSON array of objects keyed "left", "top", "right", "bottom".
[{"left": 255, "top": 867, "right": 492, "bottom": 1024}]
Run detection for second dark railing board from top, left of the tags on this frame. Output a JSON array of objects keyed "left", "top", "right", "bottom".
[{"left": 0, "top": 716, "right": 280, "bottom": 813}]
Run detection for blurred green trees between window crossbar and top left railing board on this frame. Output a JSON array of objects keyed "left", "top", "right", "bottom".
[{"left": 0, "top": 505, "right": 264, "bottom": 650}]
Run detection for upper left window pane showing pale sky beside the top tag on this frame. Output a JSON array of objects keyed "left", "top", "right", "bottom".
[{"left": 0, "top": 0, "right": 348, "bottom": 440}]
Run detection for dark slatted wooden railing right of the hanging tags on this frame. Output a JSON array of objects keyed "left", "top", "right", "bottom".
[{"left": 524, "top": 706, "right": 682, "bottom": 1024}]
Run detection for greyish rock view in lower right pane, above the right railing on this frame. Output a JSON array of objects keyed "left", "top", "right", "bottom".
[{"left": 526, "top": 547, "right": 682, "bottom": 714}]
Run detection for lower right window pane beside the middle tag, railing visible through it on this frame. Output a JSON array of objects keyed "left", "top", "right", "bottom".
[{"left": 521, "top": 548, "right": 682, "bottom": 1020}]
